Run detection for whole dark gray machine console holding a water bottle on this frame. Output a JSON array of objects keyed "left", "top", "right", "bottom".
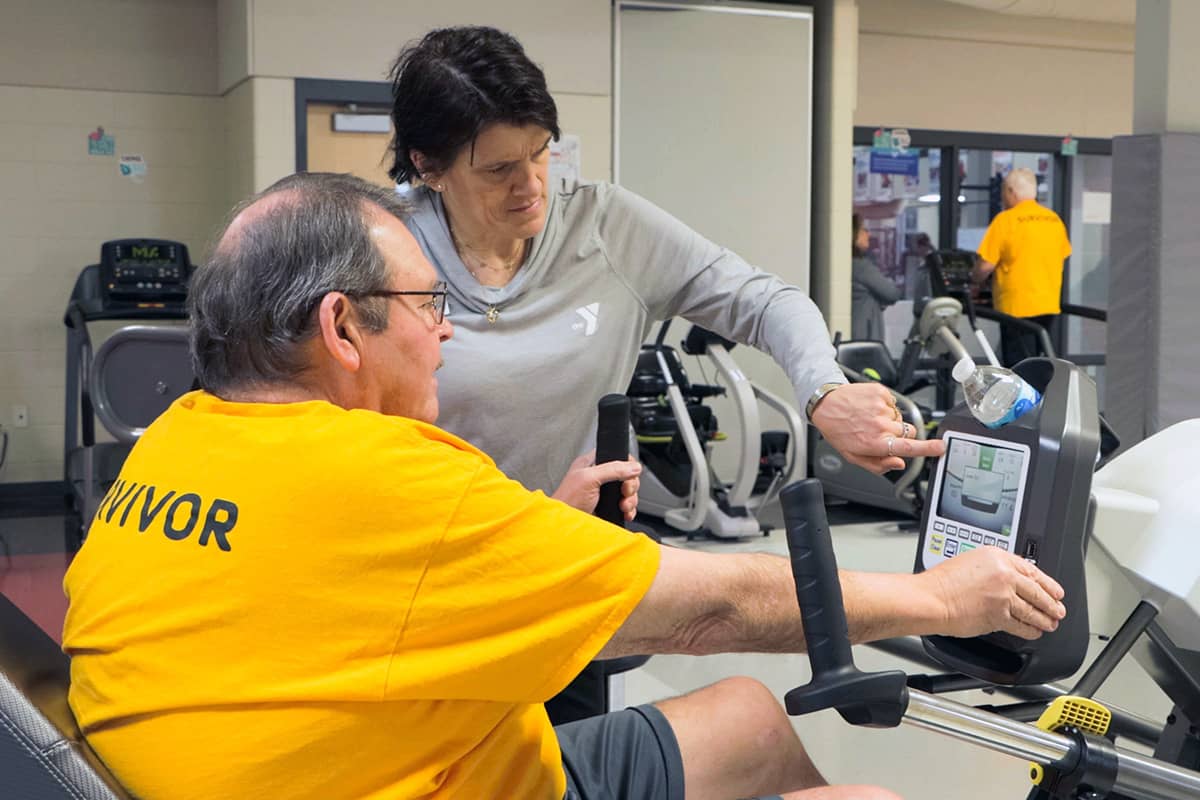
[{"left": 916, "top": 359, "right": 1100, "bottom": 685}]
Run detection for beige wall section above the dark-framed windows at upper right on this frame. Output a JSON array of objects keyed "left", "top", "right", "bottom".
[{"left": 854, "top": 0, "right": 1134, "bottom": 138}]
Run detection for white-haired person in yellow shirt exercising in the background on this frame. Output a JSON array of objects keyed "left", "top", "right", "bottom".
[{"left": 972, "top": 168, "right": 1070, "bottom": 367}]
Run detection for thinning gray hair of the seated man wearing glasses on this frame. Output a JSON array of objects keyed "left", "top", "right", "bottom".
[{"left": 187, "top": 173, "right": 410, "bottom": 395}]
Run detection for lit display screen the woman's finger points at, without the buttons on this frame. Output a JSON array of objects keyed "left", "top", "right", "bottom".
[{"left": 937, "top": 437, "right": 1025, "bottom": 536}]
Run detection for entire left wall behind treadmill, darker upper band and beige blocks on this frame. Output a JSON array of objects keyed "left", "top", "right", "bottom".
[{"left": 0, "top": 0, "right": 232, "bottom": 482}]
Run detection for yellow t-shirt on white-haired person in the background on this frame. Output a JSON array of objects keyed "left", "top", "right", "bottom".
[{"left": 978, "top": 200, "right": 1070, "bottom": 317}]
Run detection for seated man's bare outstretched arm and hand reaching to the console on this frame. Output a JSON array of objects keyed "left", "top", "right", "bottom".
[{"left": 600, "top": 547, "right": 1066, "bottom": 658}]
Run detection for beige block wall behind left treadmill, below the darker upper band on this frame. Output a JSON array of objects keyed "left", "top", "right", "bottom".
[{"left": 0, "top": 85, "right": 228, "bottom": 482}]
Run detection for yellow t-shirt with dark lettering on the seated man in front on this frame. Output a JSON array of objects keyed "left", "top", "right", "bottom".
[{"left": 62, "top": 392, "right": 658, "bottom": 800}]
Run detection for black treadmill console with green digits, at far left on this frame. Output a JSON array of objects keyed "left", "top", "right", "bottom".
[{"left": 100, "top": 239, "right": 192, "bottom": 305}]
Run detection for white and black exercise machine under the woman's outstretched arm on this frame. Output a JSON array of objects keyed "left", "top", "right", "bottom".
[{"left": 626, "top": 320, "right": 804, "bottom": 539}]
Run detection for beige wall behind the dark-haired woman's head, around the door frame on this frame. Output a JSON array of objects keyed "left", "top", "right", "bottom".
[{"left": 232, "top": 0, "right": 612, "bottom": 187}]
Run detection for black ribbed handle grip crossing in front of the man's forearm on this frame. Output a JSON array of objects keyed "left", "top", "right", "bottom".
[{"left": 779, "top": 477, "right": 854, "bottom": 679}]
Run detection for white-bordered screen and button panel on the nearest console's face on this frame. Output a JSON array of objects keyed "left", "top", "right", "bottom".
[{"left": 922, "top": 431, "right": 1030, "bottom": 570}]
